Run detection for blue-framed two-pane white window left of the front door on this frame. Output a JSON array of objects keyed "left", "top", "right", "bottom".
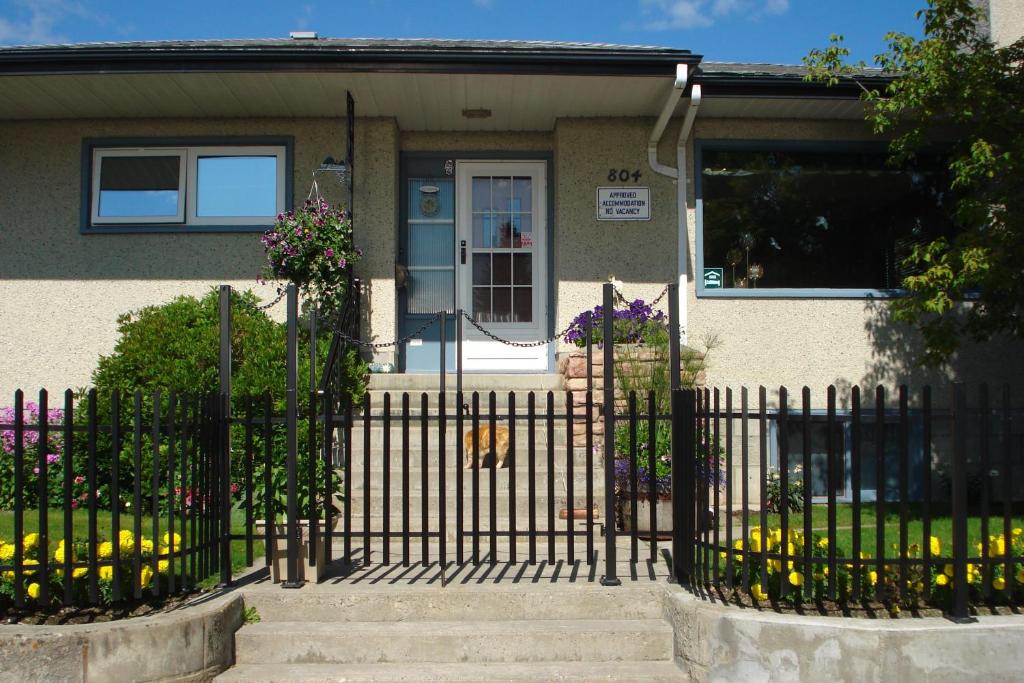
[{"left": 86, "top": 143, "right": 290, "bottom": 231}]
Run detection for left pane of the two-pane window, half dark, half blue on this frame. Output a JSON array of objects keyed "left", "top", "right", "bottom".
[{"left": 97, "top": 155, "right": 181, "bottom": 218}]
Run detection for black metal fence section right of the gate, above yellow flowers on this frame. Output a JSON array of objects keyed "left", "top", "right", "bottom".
[{"left": 676, "top": 385, "right": 1024, "bottom": 617}]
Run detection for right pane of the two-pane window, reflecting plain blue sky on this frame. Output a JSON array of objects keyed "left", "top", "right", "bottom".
[{"left": 196, "top": 157, "right": 278, "bottom": 216}]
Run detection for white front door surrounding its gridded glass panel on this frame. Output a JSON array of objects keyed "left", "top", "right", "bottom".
[{"left": 456, "top": 160, "right": 549, "bottom": 372}]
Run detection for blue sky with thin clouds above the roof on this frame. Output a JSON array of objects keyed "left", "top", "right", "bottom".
[{"left": 0, "top": 0, "right": 925, "bottom": 63}]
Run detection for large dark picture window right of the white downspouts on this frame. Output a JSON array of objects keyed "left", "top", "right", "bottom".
[{"left": 697, "top": 142, "right": 952, "bottom": 296}]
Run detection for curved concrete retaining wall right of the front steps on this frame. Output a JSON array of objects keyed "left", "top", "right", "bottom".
[{"left": 665, "top": 586, "right": 1024, "bottom": 683}]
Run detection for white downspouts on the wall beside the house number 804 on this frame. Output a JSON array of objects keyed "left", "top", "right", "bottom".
[{"left": 647, "top": 65, "right": 701, "bottom": 344}]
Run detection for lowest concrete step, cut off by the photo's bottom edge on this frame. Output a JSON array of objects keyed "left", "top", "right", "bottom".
[{"left": 216, "top": 661, "right": 688, "bottom": 683}]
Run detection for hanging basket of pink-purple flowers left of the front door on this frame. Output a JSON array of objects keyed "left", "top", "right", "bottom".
[{"left": 260, "top": 198, "right": 362, "bottom": 302}]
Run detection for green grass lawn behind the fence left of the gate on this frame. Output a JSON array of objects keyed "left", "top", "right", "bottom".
[{"left": 0, "top": 508, "right": 264, "bottom": 583}]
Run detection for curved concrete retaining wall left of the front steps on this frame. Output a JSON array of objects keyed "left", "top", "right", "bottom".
[{"left": 0, "top": 593, "right": 243, "bottom": 683}]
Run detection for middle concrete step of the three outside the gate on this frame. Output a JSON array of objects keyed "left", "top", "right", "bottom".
[{"left": 234, "top": 618, "right": 673, "bottom": 665}]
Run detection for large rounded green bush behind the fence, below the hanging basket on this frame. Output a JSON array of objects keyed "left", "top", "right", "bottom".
[{"left": 77, "top": 290, "right": 367, "bottom": 516}]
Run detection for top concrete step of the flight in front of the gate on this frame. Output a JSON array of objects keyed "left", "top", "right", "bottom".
[{"left": 244, "top": 581, "right": 662, "bottom": 630}]
